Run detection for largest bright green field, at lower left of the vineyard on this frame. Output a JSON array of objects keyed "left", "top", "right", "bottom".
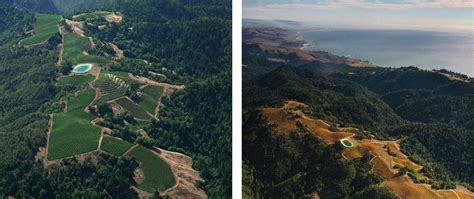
[{"left": 48, "top": 89, "right": 100, "bottom": 160}]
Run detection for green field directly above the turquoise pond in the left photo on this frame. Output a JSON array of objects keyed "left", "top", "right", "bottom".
[{"left": 63, "top": 33, "right": 109, "bottom": 64}]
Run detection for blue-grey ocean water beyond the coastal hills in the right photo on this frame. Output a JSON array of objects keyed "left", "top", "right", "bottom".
[{"left": 300, "top": 30, "right": 474, "bottom": 77}]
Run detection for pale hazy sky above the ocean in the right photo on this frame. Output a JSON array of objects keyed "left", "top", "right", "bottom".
[{"left": 243, "top": 0, "right": 474, "bottom": 31}]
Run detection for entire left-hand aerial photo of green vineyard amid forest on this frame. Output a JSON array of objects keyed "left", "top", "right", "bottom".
[{"left": 0, "top": 0, "right": 232, "bottom": 198}]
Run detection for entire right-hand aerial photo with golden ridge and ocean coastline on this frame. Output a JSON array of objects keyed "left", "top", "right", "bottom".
[{"left": 242, "top": 0, "right": 474, "bottom": 199}]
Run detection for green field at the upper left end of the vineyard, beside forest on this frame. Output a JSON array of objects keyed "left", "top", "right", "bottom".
[{"left": 21, "top": 14, "right": 61, "bottom": 46}]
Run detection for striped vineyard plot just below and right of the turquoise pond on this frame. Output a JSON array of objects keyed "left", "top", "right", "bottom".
[{"left": 94, "top": 73, "right": 127, "bottom": 103}]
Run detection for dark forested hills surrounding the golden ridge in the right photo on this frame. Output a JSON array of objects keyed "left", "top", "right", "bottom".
[{"left": 243, "top": 40, "right": 474, "bottom": 198}]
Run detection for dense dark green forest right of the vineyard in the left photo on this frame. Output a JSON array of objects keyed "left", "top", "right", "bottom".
[{"left": 100, "top": 0, "right": 232, "bottom": 198}]
